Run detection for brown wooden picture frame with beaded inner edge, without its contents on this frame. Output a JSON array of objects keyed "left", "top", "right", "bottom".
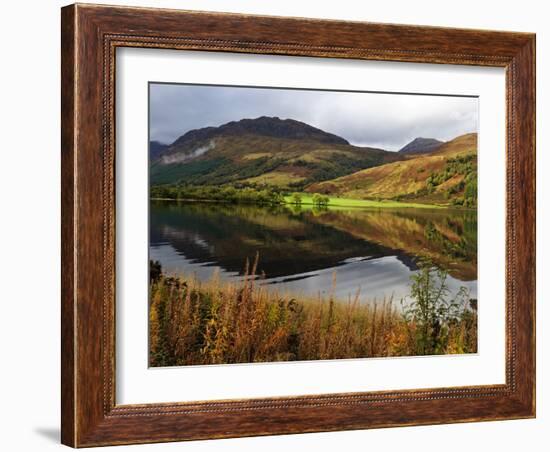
[{"left": 61, "top": 4, "right": 535, "bottom": 447}]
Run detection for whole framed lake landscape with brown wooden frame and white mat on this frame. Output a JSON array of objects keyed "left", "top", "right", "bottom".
[{"left": 61, "top": 4, "right": 535, "bottom": 447}]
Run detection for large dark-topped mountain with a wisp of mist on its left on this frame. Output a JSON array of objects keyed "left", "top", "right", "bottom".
[{"left": 150, "top": 116, "right": 404, "bottom": 190}]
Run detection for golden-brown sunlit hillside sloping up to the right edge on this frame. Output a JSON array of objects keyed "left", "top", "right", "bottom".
[{"left": 307, "top": 133, "right": 477, "bottom": 206}]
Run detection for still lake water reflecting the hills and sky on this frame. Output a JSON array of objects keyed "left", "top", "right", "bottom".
[{"left": 149, "top": 201, "right": 477, "bottom": 303}]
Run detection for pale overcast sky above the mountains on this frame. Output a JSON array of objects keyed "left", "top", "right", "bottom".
[{"left": 150, "top": 84, "right": 478, "bottom": 151}]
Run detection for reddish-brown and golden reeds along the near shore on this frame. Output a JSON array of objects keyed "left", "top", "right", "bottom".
[{"left": 149, "top": 254, "right": 477, "bottom": 367}]
